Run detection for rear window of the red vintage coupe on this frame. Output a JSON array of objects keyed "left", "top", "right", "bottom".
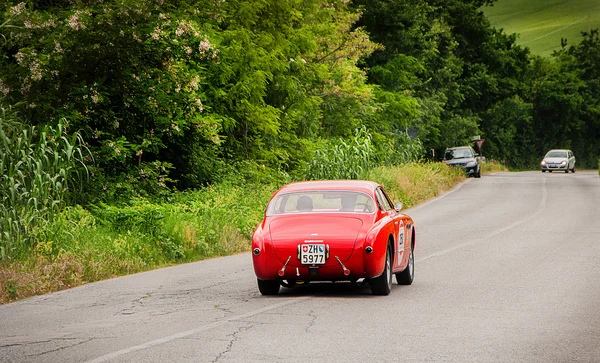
[{"left": 267, "top": 191, "right": 375, "bottom": 216}]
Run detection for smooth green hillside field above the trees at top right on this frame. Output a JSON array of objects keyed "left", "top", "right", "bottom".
[{"left": 482, "top": 0, "right": 600, "bottom": 56}]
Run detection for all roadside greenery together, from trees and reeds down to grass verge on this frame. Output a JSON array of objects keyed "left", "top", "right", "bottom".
[{"left": 0, "top": 0, "right": 600, "bottom": 297}]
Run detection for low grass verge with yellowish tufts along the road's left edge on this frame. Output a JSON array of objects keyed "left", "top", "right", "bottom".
[{"left": 0, "top": 163, "right": 465, "bottom": 303}]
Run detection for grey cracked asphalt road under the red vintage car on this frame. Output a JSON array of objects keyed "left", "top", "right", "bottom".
[{"left": 0, "top": 171, "right": 600, "bottom": 362}]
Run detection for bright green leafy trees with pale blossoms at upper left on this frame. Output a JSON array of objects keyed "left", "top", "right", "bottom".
[{"left": 0, "top": 0, "right": 378, "bottom": 193}]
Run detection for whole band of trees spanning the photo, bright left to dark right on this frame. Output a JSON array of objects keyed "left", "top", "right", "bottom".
[{"left": 0, "top": 0, "right": 600, "bottom": 196}]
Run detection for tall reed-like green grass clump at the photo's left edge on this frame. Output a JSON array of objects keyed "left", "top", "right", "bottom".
[{"left": 0, "top": 108, "right": 87, "bottom": 260}]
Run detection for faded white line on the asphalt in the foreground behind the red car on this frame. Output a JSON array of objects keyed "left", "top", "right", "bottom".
[{"left": 85, "top": 297, "right": 310, "bottom": 363}]
